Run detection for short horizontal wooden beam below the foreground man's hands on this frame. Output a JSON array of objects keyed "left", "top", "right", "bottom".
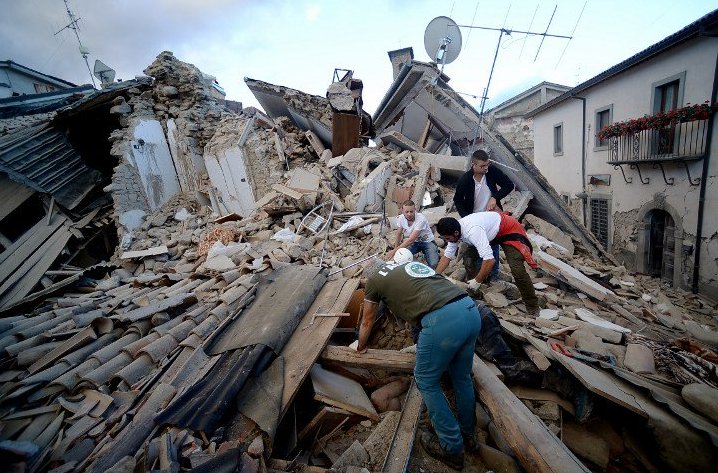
[{"left": 320, "top": 346, "right": 416, "bottom": 373}]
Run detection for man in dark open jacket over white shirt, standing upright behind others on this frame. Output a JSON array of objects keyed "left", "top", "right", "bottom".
[{"left": 454, "top": 149, "right": 515, "bottom": 280}]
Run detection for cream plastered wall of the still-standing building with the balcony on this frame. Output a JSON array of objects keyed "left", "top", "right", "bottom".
[{"left": 534, "top": 38, "right": 718, "bottom": 295}]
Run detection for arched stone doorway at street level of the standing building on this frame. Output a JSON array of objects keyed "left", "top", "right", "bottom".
[{"left": 636, "top": 195, "right": 685, "bottom": 287}]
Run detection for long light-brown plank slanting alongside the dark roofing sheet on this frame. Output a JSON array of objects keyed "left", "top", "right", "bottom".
[{"left": 280, "top": 278, "right": 359, "bottom": 417}]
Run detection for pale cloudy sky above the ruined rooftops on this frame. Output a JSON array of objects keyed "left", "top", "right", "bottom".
[{"left": 0, "top": 0, "right": 717, "bottom": 112}]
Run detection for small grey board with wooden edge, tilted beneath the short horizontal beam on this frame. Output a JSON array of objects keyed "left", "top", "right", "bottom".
[{"left": 310, "top": 364, "right": 379, "bottom": 422}]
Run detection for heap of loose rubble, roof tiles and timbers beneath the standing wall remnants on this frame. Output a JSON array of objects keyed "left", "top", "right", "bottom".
[{"left": 0, "top": 48, "right": 718, "bottom": 473}]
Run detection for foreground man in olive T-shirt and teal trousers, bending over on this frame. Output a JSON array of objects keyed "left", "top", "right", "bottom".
[{"left": 357, "top": 261, "right": 481, "bottom": 470}]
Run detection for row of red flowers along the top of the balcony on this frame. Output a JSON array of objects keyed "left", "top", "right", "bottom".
[{"left": 598, "top": 100, "right": 718, "bottom": 140}]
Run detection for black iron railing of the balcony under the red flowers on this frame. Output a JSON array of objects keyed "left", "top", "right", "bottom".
[{"left": 608, "top": 119, "right": 708, "bottom": 164}]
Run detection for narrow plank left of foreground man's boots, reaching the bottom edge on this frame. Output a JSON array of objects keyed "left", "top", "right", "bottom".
[{"left": 381, "top": 380, "right": 423, "bottom": 473}]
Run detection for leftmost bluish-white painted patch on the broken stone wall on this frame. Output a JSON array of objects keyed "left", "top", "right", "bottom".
[{"left": 128, "top": 120, "right": 180, "bottom": 210}]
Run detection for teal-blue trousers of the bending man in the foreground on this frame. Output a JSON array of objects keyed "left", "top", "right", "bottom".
[{"left": 414, "top": 296, "right": 481, "bottom": 453}]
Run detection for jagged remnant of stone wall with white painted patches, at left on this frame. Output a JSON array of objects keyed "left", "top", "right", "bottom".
[{"left": 110, "top": 51, "right": 236, "bottom": 233}]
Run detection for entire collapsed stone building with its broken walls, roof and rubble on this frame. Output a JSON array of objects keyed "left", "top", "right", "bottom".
[{"left": 0, "top": 47, "right": 718, "bottom": 472}]
